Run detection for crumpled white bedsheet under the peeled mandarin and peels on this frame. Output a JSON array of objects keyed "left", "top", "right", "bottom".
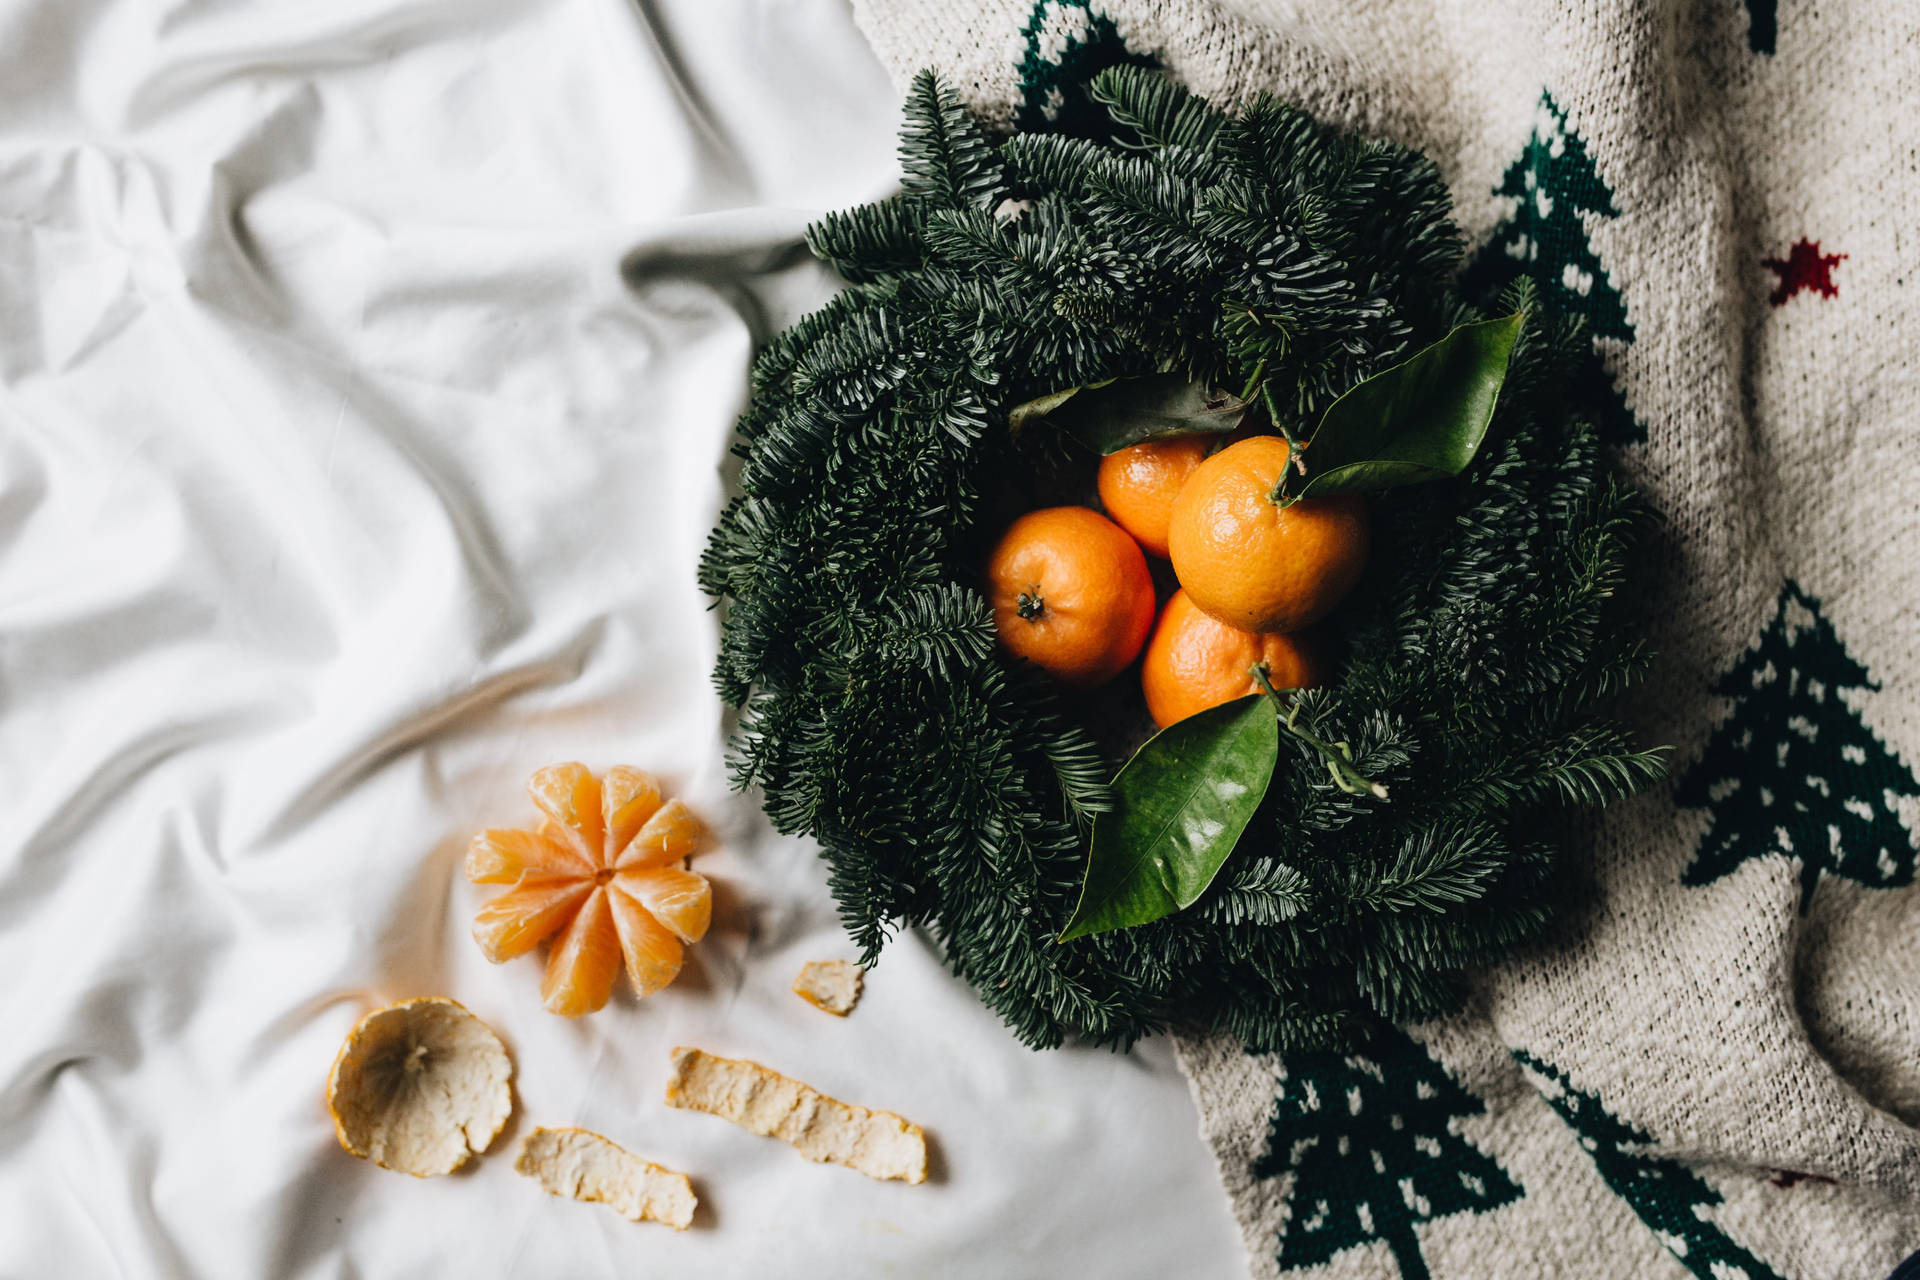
[{"left": 0, "top": 0, "right": 1240, "bottom": 1280}]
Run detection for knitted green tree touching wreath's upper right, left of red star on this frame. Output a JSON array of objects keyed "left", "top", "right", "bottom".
[{"left": 1461, "top": 94, "right": 1647, "bottom": 445}]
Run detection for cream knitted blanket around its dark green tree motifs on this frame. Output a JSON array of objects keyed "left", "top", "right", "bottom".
[{"left": 854, "top": 0, "right": 1920, "bottom": 1280}]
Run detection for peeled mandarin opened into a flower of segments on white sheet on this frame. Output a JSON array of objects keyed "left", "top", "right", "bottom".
[{"left": 467, "top": 764, "right": 712, "bottom": 1017}]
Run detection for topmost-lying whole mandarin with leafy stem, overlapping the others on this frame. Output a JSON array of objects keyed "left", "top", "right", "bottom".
[{"left": 1167, "top": 436, "right": 1367, "bottom": 631}]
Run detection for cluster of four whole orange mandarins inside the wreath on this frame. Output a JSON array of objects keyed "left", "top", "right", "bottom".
[{"left": 987, "top": 436, "right": 1369, "bottom": 727}]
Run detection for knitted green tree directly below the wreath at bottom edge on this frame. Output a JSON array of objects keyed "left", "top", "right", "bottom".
[{"left": 1254, "top": 1031, "right": 1523, "bottom": 1280}]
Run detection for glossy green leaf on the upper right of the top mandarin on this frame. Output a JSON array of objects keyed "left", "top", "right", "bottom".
[{"left": 1298, "top": 311, "right": 1526, "bottom": 497}]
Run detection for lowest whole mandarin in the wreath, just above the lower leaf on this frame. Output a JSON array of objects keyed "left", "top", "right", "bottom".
[{"left": 1140, "top": 591, "right": 1327, "bottom": 729}]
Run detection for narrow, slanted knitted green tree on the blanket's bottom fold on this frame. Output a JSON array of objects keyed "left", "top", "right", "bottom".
[{"left": 1513, "top": 1050, "right": 1782, "bottom": 1280}]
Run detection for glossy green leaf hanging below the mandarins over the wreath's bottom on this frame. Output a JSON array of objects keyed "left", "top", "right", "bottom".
[{"left": 1060, "top": 695, "right": 1281, "bottom": 942}]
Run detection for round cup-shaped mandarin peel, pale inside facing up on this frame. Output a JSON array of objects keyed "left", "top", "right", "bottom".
[{"left": 326, "top": 996, "right": 513, "bottom": 1178}]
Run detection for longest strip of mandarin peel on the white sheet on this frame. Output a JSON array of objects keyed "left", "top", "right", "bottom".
[{"left": 666, "top": 1046, "right": 927, "bottom": 1182}]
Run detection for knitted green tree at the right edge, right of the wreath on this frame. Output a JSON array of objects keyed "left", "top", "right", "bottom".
[{"left": 1674, "top": 581, "right": 1920, "bottom": 912}]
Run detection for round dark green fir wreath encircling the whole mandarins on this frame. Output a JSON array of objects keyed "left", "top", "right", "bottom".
[{"left": 701, "top": 67, "right": 1663, "bottom": 1050}]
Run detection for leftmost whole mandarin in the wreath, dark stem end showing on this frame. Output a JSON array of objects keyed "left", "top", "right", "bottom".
[{"left": 987, "top": 507, "right": 1154, "bottom": 687}]
